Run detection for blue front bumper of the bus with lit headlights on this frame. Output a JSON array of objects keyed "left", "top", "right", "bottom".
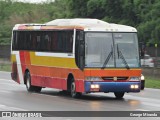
[{"left": 85, "top": 81, "right": 141, "bottom": 93}]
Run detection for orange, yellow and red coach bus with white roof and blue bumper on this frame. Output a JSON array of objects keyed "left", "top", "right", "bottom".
[{"left": 11, "top": 18, "right": 141, "bottom": 98}]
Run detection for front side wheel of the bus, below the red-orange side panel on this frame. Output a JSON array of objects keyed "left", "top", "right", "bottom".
[{"left": 71, "top": 80, "right": 81, "bottom": 98}]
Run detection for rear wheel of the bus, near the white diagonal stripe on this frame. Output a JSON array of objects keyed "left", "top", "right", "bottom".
[{"left": 25, "top": 72, "right": 42, "bottom": 92}]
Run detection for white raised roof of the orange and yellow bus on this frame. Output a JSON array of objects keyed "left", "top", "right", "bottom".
[{"left": 13, "top": 18, "right": 137, "bottom": 32}]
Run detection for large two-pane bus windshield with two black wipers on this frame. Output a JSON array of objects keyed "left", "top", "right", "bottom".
[{"left": 85, "top": 32, "right": 140, "bottom": 69}]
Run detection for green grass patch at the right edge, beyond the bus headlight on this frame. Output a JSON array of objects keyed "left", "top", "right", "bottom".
[{"left": 145, "top": 76, "right": 160, "bottom": 89}]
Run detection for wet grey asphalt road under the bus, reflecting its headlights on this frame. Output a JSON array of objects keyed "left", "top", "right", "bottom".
[{"left": 0, "top": 72, "right": 160, "bottom": 120}]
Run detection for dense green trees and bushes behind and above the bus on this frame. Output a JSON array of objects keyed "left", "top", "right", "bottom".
[{"left": 0, "top": 0, "right": 160, "bottom": 46}]
